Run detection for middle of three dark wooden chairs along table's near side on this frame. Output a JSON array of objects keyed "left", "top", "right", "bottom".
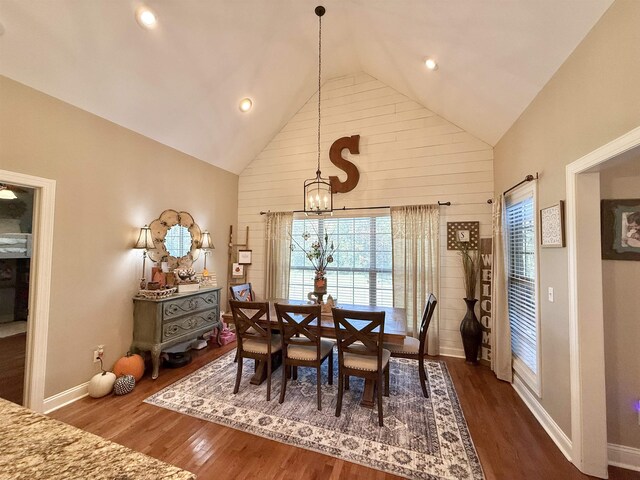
[{"left": 275, "top": 303, "right": 335, "bottom": 410}]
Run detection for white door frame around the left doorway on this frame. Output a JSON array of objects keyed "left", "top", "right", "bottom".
[{"left": 0, "top": 170, "right": 56, "bottom": 412}]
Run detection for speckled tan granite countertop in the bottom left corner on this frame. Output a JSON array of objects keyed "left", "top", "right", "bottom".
[{"left": 0, "top": 399, "right": 196, "bottom": 480}]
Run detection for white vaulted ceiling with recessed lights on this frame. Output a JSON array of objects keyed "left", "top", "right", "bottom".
[{"left": 0, "top": 0, "right": 613, "bottom": 173}]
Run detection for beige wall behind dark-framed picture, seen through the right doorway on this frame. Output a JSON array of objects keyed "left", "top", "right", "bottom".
[{"left": 600, "top": 159, "right": 640, "bottom": 448}]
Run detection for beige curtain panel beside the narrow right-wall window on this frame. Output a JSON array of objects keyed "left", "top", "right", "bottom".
[{"left": 491, "top": 195, "right": 513, "bottom": 383}]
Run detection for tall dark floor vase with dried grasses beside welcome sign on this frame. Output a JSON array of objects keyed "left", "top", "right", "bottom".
[{"left": 459, "top": 242, "right": 482, "bottom": 364}]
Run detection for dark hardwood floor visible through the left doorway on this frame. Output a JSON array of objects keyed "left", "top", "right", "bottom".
[{"left": 0, "top": 333, "right": 27, "bottom": 404}]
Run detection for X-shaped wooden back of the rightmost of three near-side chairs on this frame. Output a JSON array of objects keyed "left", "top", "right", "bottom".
[{"left": 331, "top": 308, "right": 385, "bottom": 360}]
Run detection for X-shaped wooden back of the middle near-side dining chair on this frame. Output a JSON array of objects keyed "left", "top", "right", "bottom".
[{"left": 275, "top": 303, "right": 322, "bottom": 348}]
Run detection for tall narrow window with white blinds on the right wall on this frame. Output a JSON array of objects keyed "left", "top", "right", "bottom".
[{"left": 505, "top": 185, "right": 540, "bottom": 394}]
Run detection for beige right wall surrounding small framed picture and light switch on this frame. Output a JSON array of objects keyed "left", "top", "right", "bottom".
[{"left": 494, "top": 0, "right": 640, "bottom": 436}]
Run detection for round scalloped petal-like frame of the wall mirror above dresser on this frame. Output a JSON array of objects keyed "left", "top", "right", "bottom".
[{"left": 147, "top": 209, "right": 202, "bottom": 269}]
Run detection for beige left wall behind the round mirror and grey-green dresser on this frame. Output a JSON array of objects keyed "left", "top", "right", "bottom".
[{"left": 0, "top": 77, "right": 238, "bottom": 397}]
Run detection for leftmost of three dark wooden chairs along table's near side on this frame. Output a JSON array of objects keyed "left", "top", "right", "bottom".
[{"left": 229, "top": 300, "right": 282, "bottom": 401}]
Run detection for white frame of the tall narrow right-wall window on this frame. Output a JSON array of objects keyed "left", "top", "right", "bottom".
[{"left": 504, "top": 181, "right": 542, "bottom": 398}]
